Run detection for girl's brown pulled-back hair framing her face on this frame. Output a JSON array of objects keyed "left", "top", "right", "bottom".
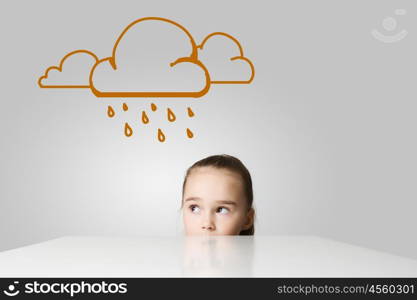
[{"left": 182, "top": 154, "right": 255, "bottom": 235}]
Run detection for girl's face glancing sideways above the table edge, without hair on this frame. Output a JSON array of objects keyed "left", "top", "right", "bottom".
[{"left": 182, "top": 167, "right": 254, "bottom": 235}]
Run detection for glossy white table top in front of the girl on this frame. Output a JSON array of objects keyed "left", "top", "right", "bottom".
[{"left": 0, "top": 236, "right": 417, "bottom": 278}]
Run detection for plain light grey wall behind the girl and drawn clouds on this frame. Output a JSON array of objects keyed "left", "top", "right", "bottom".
[{"left": 0, "top": 0, "right": 417, "bottom": 258}]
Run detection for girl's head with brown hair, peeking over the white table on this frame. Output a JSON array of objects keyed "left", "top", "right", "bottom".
[{"left": 181, "top": 155, "right": 255, "bottom": 235}]
